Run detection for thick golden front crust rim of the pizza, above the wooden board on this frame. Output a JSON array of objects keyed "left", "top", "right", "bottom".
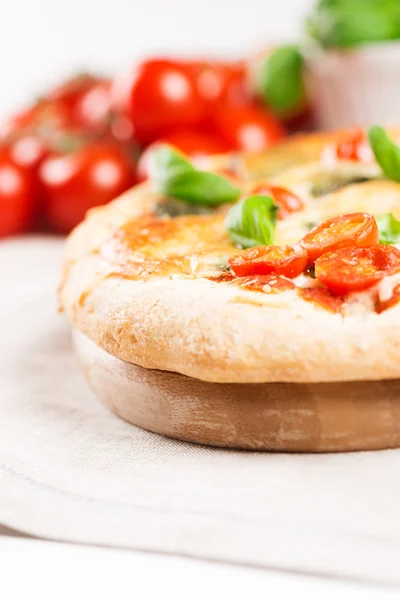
[{"left": 61, "top": 244, "right": 400, "bottom": 383}]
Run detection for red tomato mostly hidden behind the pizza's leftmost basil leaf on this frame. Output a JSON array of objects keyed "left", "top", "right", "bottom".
[{"left": 136, "top": 131, "right": 229, "bottom": 181}]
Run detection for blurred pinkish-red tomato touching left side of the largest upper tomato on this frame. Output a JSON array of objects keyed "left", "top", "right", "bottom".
[{"left": 74, "top": 79, "right": 111, "bottom": 131}]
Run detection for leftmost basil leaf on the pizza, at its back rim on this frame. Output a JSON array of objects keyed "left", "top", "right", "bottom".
[{"left": 149, "top": 145, "right": 240, "bottom": 206}]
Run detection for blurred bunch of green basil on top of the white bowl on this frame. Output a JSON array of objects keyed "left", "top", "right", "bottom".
[{"left": 307, "top": 0, "right": 400, "bottom": 48}]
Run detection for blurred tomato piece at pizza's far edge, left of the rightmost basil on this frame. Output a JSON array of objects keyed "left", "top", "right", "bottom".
[{"left": 321, "top": 129, "right": 374, "bottom": 163}]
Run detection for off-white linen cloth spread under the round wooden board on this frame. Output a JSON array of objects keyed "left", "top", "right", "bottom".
[{"left": 0, "top": 238, "right": 400, "bottom": 584}]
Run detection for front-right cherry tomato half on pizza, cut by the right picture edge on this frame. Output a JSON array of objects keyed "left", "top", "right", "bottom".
[{"left": 315, "top": 244, "right": 400, "bottom": 295}]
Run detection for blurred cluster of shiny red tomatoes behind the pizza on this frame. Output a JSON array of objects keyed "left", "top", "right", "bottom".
[{"left": 0, "top": 59, "right": 300, "bottom": 236}]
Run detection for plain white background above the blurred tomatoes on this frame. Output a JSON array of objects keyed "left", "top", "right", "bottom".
[{"left": 0, "top": 0, "right": 313, "bottom": 117}]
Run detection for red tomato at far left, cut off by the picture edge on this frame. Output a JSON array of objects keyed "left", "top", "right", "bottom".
[{"left": 0, "top": 152, "right": 35, "bottom": 236}]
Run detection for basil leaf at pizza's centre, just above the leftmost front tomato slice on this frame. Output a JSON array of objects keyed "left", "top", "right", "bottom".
[{"left": 225, "top": 196, "right": 278, "bottom": 248}]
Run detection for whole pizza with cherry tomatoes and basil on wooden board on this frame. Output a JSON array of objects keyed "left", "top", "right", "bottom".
[{"left": 59, "top": 128, "right": 400, "bottom": 383}]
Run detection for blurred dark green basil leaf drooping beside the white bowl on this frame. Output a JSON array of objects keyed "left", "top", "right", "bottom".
[{"left": 258, "top": 46, "right": 306, "bottom": 117}]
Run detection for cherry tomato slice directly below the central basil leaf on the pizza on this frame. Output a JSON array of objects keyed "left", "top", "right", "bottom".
[{"left": 228, "top": 246, "right": 308, "bottom": 279}]
